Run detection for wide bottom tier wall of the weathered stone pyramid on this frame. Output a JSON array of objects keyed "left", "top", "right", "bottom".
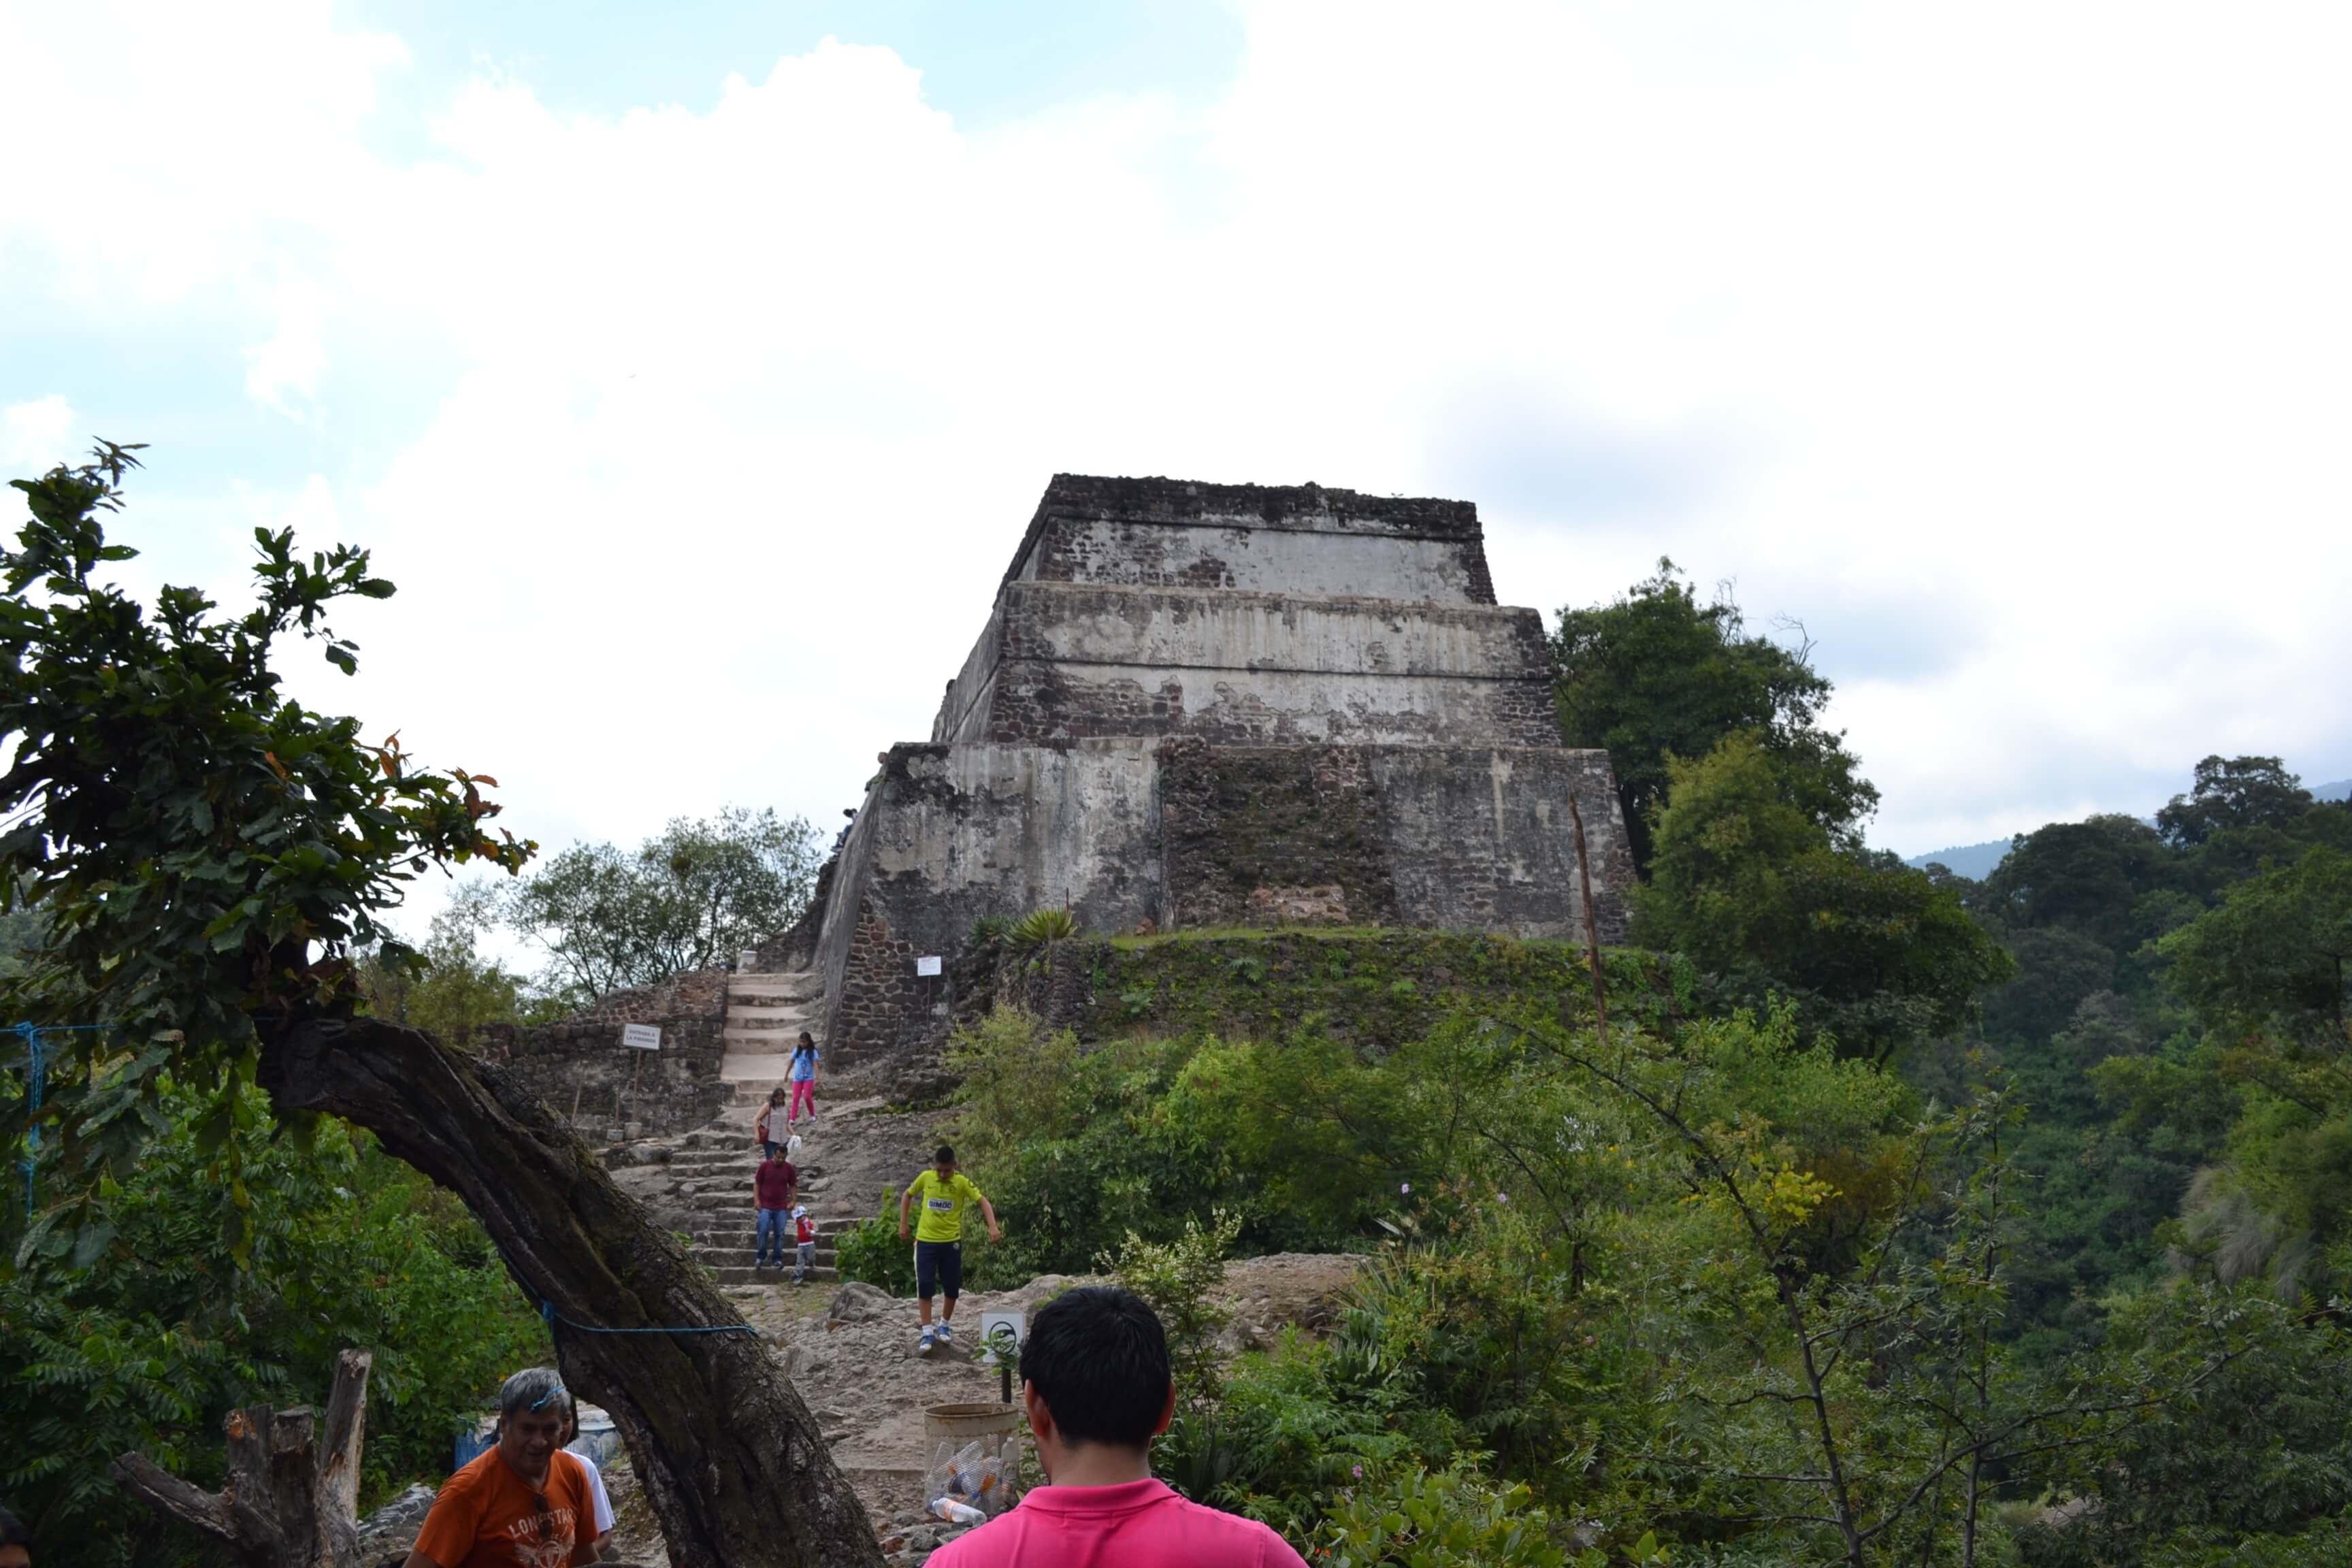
[{"left": 823, "top": 738, "right": 1630, "bottom": 1065}]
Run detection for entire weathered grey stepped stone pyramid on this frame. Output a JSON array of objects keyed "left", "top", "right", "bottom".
[{"left": 776, "top": 475, "right": 1630, "bottom": 1065}]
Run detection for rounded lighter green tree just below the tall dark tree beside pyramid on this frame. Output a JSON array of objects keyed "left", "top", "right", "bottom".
[{"left": 1635, "top": 731, "right": 2011, "bottom": 1058}]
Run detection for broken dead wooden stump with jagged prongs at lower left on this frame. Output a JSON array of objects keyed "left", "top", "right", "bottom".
[{"left": 115, "top": 1350, "right": 374, "bottom": 1568}]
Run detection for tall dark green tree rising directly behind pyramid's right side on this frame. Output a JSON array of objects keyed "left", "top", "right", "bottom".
[{"left": 1552, "top": 559, "right": 1879, "bottom": 872}]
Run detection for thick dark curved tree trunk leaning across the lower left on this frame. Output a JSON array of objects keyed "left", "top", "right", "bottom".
[{"left": 261, "top": 1018, "right": 882, "bottom": 1568}]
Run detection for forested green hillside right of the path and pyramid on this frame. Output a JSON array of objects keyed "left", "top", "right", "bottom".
[{"left": 845, "top": 569, "right": 2352, "bottom": 1568}]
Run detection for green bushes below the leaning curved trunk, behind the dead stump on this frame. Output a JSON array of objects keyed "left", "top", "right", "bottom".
[{"left": 0, "top": 1088, "right": 551, "bottom": 1568}]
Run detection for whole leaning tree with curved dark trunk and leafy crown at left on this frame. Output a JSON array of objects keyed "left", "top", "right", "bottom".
[{"left": 0, "top": 446, "right": 880, "bottom": 1568}]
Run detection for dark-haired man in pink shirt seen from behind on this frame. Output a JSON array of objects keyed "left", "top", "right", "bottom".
[{"left": 932, "top": 1286, "right": 1305, "bottom": 1568}]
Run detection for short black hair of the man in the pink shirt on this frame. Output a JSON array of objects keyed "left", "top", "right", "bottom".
[{"left": 1021, "top": 1286, "right": 1169, "bottom": 1448}]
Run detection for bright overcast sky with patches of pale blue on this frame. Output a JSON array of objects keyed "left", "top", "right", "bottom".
[{"left": 0, "top": 0, "right": 2352, "bottom": 930}]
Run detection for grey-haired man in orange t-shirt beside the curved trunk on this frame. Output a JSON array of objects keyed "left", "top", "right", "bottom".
[{"left": 407, "top": 1366, "right": 595, "bottom": 1568}]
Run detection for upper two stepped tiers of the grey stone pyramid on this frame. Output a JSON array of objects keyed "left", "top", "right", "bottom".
[{"left": 932, "top": 475, "right": 1559, "bottom": 745}]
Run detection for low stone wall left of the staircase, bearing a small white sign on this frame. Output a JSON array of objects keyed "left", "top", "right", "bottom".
[{"left": 475, "top": 968, "right": 732, "bottom": 1143}]
